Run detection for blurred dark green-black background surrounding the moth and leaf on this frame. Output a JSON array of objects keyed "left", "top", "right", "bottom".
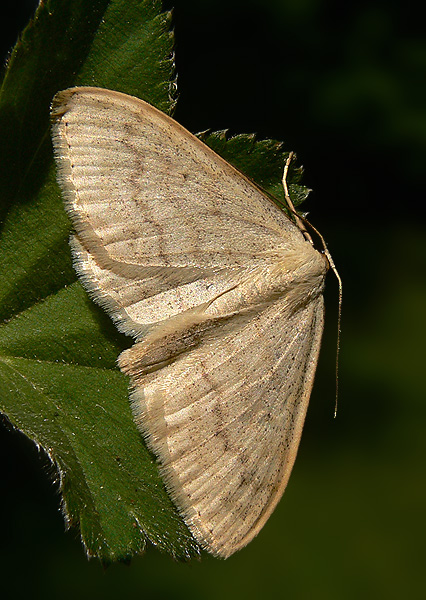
[{"left": 0, "top": 0, "right": 426, "bottom": 600}]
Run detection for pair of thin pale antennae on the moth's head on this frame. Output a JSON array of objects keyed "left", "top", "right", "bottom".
[{"left": 282, "top": 152, "right": 343, "bottom": 418}]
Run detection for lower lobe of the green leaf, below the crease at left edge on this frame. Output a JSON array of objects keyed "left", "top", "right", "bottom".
[{"left": 0, "top": 283, "right": 196, "bottom": 562}]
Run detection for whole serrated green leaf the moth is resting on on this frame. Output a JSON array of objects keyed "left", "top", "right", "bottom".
[{"left": 0, "top": 0, "right": 307, "bottom": 563}]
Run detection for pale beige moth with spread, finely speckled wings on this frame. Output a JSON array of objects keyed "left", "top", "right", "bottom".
[{"left": 52, "top": 87, "right": 331, "bottom": 557}]
